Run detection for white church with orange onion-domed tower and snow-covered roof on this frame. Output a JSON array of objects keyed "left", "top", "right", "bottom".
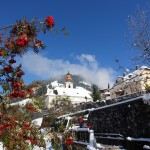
[{"left": 46, "top": 71, "right": 93, "bottom": 108}]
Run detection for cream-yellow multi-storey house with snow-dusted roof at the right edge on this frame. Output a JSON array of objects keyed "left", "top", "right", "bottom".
[{"left": 110, "top": 66, "right": 150, "bottom": 99}]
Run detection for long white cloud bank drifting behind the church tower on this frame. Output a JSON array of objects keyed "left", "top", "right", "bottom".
[{"left": 20, "top": 54, "right": 115, "bottom": 88}]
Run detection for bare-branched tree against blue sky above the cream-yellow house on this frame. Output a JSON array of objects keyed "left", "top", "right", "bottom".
[{"left": 128, "top": 5, "right": 150, "bottom": 65}]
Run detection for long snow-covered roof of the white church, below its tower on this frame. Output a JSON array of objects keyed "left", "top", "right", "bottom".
[{"left": 46, "top": 87, "right": 92, "bottom": 98}]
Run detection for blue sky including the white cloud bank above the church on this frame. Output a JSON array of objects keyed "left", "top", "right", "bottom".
[{"left": 0, "top": 0, "right": 149, "bottom": 88}]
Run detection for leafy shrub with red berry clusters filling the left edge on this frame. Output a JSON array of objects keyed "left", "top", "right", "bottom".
[{"left": 0, "top": 16, "right": 54, "bottom": 149}]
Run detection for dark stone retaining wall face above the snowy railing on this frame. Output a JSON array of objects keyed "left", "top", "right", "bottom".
[{"left": 89, "top": 98, "right": 150, "bottom": 138}]
